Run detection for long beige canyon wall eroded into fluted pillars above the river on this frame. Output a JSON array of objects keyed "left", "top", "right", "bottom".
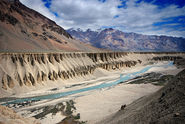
[{"left": 0, "top": 52, "right": 185, "bottom": 96}]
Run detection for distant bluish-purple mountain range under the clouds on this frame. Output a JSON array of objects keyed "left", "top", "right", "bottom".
[{"left": 67, "top": 28, "right": 185, "bottom": 51}]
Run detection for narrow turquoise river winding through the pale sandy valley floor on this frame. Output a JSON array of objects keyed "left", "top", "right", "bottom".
[{"left": 2, "top": 62, "right": 173, "bottom": 105}]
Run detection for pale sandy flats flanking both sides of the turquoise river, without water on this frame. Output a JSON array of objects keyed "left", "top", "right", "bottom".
[{"left": 0, "top": 59, "right": 182, "bottom": 124}]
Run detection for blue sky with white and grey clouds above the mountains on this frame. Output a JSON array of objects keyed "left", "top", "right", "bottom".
[{"left": 20, "top": 0, "right": 185, "bottom": 37}]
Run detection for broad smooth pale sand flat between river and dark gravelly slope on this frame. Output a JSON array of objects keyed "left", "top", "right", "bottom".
[{"left": 75, "top": 84, "right": 161, "bottom": 124}]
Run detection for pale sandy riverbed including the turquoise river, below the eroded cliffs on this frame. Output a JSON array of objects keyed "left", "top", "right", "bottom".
[{"left": 1, "top": 62, "right": 180, "bottom": 123}]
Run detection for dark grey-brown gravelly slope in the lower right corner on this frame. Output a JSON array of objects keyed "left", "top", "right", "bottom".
[{"left": 97, "top": 70, "right": 185, "bottom": 124}]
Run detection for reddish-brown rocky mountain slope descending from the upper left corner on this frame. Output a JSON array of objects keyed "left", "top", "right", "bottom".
[{"left": 0, "top": 0, "right": 98, "bottom": 52}]
